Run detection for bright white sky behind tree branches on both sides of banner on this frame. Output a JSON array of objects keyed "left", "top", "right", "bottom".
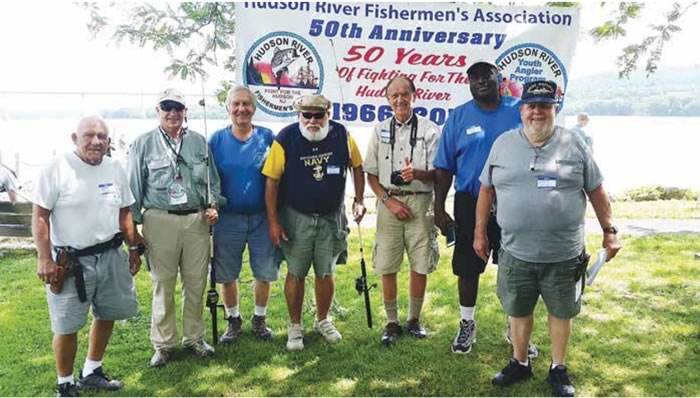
[{"left": 0, "top": 1, "right": 700, "bottom": 99}]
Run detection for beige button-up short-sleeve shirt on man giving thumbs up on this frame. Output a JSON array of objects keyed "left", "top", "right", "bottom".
[{"left": 363, "top": 116, "right": 440, "bottom": 192}]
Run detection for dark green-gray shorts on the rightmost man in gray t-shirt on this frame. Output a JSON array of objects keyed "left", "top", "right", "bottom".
[{"left": 497, "top": 249, "right": 582, "bottom": 319}]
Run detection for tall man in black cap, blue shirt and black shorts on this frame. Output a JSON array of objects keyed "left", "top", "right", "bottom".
[{"left": 433, "top": 61, "right": 520, "bottom": 354}]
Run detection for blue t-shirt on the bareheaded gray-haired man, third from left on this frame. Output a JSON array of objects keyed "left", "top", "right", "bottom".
[{"left": 209, "top": 126, "right": 275, "bottom": 214}]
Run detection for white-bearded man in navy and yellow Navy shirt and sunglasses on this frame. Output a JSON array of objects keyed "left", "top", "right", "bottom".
[{"left": 263, "top": 95, "right": 365, "bottom": 351}]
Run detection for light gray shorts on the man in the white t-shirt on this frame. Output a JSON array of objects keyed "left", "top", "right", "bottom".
[{"left": 46, "top": 248, "right": 138, "bottom": 335}]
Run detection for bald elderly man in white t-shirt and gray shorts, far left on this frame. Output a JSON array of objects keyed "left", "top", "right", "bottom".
[{"left": 32, "top": 117, "right": 145, "bottom": 396}]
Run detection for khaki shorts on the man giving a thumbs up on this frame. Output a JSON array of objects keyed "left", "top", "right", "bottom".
[{"left": 372, "top": 194, "right": 440, "bottom": 275}]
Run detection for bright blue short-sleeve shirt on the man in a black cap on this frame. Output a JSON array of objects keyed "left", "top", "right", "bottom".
[{"left": 433, "top": 96, "right": 521, "bottom": 197}]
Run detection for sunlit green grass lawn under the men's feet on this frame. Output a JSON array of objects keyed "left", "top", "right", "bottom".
[{"left": 0, "top": 230, "right": 700, "bottom": 396}]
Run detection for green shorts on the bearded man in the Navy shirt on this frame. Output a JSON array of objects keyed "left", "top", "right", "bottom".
[{"left": 280, "top": 206, "right": 350, "bottom": 278}]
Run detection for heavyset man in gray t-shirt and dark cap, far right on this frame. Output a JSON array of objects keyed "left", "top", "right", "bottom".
[{"left": 474, "top": 81, "right": 620, "bottom": 396}]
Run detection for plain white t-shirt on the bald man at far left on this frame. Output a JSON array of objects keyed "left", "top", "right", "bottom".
[{"left": 33, "top": 152, "right": 134, "bottom": 249}]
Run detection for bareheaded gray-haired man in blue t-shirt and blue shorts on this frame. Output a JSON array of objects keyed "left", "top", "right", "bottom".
[{"left": 209, "top": 86, "right": 279, "bottom": 343}]
